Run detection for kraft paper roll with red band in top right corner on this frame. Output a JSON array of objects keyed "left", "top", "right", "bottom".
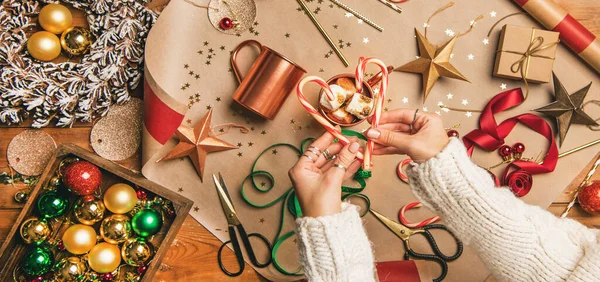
[{"left": 513, "top": 0, "right": 600, "bottom": 72}]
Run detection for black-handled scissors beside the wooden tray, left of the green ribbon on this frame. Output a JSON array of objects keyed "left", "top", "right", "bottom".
[{"left": 213, "top": 173, "right": 271, "bottom": 277}]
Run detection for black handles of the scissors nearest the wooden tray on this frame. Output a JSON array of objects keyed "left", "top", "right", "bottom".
[{"left": 217, "top": 224, "right": 271, "bottom": 277}]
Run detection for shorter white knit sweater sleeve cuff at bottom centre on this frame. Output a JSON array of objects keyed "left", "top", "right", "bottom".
[{"left": 296, "top": 203, "right": 375, "bottom": 282}]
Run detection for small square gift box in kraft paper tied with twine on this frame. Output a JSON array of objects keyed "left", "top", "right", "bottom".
[{"left": 494, "top": 25, "right": 559, "bottom": 83}]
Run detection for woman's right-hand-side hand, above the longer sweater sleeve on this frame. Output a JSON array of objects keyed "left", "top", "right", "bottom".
[{"left": 365, "top": 109, "right": 450, "bottom": 163}]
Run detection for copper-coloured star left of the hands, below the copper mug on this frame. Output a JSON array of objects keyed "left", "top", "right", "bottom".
[{"left": 156, "top": 109, "right": 238, "bottom": 181}]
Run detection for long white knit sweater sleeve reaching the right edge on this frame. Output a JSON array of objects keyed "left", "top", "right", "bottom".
[{"left": 408, "top": 138, "right": 600, "bottom": 281}]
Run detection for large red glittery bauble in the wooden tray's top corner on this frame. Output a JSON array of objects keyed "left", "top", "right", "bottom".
[{"left": 63, "top": 161, "right": 102, "bottom": 196}]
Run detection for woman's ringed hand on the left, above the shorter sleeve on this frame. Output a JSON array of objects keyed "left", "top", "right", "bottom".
[{"left": 289, "top": 132, "right": 361, "bottom": 217}]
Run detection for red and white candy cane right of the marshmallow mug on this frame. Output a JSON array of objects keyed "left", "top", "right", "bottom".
[{"left": 355, "top": 57, "right": 389, "bottom": 171}]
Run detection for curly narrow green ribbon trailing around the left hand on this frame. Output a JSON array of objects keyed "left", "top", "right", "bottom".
[{"left": 240, "top": 129, "right": 371, "bottom": 276}]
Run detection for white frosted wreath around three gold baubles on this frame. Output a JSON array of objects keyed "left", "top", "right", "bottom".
[{"left": 0, "top": 0, "right": 158, "bottom": 127}]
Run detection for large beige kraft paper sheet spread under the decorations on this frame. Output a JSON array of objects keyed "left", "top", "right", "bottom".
[{"left": 143, "top": 0, "right": 600, "bottom": 281}]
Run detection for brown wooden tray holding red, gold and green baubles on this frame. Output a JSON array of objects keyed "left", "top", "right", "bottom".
[{"left": 0, "top": 144, "right": 193, "bottom": 281}]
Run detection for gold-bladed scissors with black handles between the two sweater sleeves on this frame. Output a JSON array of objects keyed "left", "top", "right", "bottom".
[{"left": 369, "top": 209, "right": 463, "bottom": 282}]
